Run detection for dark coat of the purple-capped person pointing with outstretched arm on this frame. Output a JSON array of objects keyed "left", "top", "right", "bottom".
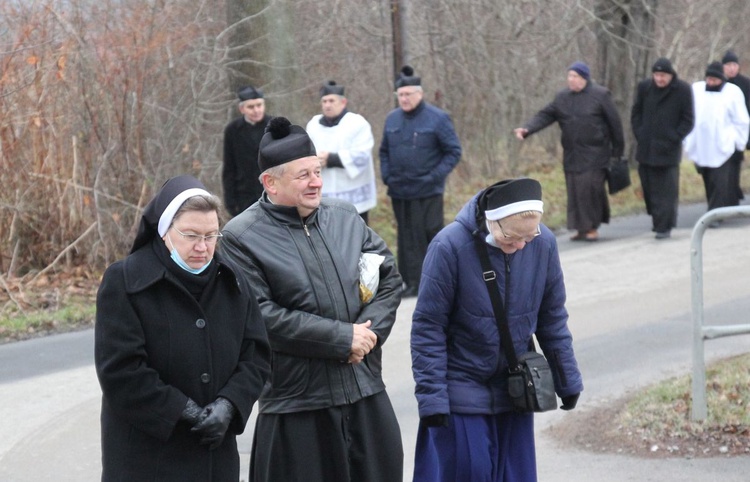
[{"left": 525, "top": 82, "right": 625, "bottom": 172}]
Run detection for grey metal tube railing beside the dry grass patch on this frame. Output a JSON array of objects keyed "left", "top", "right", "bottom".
[{"left": 690, "top": 206, "right": 750, "bottom": 421}]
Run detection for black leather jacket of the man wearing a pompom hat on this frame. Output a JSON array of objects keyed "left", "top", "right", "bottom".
[{"left": 221, "top": 194, "right": 401, "bottom": 413}]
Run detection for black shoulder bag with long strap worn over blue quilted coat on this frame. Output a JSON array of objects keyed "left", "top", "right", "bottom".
[{"left": 474, "top": 235, "right": 557, "bottom": 413}]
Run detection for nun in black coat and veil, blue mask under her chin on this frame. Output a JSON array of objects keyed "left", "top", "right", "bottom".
[{"left": 95, "top": 176, "right": 270, "bottom": 482}]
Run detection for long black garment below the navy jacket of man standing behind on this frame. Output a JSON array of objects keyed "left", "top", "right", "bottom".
[{"left": 391, "top": 194, "right": 443, "bottom": 288}]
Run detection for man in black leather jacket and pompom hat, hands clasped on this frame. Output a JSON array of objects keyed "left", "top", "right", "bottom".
[{"left": 222, "top": 117, "right": 403, "bottom": 482}]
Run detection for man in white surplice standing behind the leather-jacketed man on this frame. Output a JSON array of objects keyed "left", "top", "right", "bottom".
[{"left": 306, "top": 80, "right": 378, "bottom": 222}]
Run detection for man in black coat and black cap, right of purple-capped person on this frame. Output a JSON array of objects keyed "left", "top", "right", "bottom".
[{"left": 630, "top": 58, "right": 695, "bottom": 239}]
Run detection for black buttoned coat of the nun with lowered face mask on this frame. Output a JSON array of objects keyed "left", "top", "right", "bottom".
[{"left": 95, "top": 243, "right": 270, "bottom": 482}]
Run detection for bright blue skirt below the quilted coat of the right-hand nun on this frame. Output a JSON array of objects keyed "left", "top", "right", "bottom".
[{"left": 414, "top": 412, "right": 536, "bottom": 482}]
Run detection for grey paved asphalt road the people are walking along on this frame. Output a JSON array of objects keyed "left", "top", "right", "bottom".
[{"left": 0, "top": 201, "right": 750, "bottom": 482}]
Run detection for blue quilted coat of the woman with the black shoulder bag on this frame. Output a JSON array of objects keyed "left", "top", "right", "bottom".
[{"left": 411, "top": 196, "right": 583, "bottom": 417}]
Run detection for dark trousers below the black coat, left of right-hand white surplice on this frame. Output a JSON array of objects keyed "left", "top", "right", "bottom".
[{"left": 638, "top": 164, "right": 680, "bottom": 233}]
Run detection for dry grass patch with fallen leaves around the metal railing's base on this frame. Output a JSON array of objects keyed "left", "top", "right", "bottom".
[{"left": 551, "top": 354, "right": 750, "bottom": 458}]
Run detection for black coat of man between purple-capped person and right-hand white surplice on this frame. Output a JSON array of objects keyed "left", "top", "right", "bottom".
[{"left": 630, "top": 75, "right": 695, "bottom": 167}]
